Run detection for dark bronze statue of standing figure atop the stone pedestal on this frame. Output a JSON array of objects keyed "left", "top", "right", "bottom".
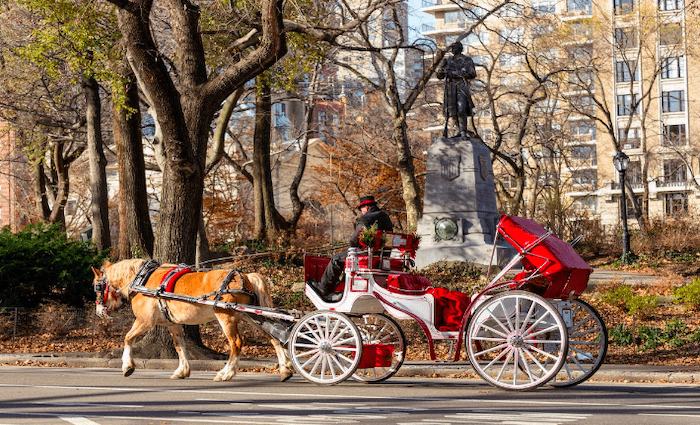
[{"left": 437, "top": 42, "right": 476, "bottom": 137}]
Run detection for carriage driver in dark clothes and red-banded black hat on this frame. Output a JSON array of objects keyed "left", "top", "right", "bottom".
[{"left": 308, "top": 196, "right": 394, "bottom": 302}]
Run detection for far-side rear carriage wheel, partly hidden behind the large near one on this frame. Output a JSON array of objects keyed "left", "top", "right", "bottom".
[{"left": 550, "top": 299, "right": 608, "bottom": 387}]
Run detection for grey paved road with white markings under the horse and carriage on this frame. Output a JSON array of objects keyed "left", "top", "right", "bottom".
[{"left": 0, "top": 367, "right": 700, "bottom": 425}]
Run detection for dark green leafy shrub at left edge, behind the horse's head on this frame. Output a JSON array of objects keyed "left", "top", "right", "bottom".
[{"left": 0, "top": 223, "right": 106, "bottom": 307}]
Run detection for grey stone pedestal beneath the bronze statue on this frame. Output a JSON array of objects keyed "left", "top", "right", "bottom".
[{"left": 416, "top": 137, "right": 513, "bottom": 269}]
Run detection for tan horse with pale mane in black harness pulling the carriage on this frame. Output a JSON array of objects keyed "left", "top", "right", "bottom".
[{"left": 92, "top": 259, "right": 293, "bottom": 381}]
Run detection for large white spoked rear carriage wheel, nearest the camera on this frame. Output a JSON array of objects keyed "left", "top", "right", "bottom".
[{"left": 466, "top": 291, "right": 568, "bottom": 390}]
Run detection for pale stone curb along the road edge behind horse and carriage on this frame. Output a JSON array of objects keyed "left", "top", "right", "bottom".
[{"left": 0, "top": 353, "right": 700, "bottom": 384}]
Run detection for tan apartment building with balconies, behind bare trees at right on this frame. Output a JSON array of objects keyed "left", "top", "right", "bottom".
[{"left": 421, "top": 0, "right": 700, "bottom": 232}]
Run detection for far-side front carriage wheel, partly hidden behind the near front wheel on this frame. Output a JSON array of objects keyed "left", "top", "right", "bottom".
[{"left": 353, "top": 314, "right": 406, "bottom": 383}]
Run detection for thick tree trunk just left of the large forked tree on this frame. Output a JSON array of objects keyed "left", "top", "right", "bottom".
[{"left": 114, "top": 59, "right": 153, "bottom": 259}]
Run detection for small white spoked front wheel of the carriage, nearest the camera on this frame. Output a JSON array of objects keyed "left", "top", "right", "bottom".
[{"left": 289, "top": 311, "right": 362, "bottom": 385}]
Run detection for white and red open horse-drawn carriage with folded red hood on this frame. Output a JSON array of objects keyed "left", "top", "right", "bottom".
[{"left": 96, "top": 216, "right": 607, "bottom": 390}]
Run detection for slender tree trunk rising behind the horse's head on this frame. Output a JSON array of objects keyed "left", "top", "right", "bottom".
[{"left": 82, "top": 77, "right": 112, "bottom": 251}]
